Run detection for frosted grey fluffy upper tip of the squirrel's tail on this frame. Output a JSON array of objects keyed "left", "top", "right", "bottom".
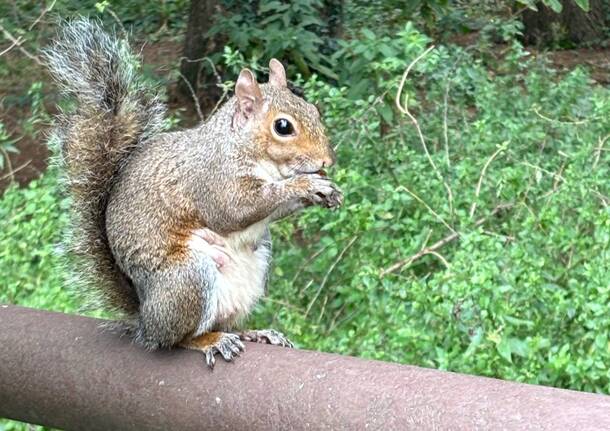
[{"left": 43, "top": 17, "right": 165, "bottom": 137}]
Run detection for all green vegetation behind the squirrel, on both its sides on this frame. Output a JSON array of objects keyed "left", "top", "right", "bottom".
[{"left": 0, "top": 0, "right": 610, "bottom": 429}]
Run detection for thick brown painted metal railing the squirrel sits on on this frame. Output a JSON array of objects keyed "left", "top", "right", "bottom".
[{"left": 0, "top": 306, "right": 610, "bottom": 430}]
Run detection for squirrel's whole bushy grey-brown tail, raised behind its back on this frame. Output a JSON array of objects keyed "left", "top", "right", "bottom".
[{"left": 44, "top": 19, "right": 165, "bottom": 314}]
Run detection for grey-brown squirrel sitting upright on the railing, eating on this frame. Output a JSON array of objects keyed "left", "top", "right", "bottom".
[{"left": 43, "top": 18, "right": 343, "bottom": 368}]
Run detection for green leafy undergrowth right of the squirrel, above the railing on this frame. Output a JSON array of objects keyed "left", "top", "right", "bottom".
[{"left": 248, "top": 28, "right": 610, "bottom": 393}]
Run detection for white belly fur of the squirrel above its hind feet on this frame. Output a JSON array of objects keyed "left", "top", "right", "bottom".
[{"left": 190, "top": 220, "right": 270, "bottom": 335}]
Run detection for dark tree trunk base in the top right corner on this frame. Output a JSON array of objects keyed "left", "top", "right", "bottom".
[{"left": 522, "top": 0, "right": 607, "bottom": 45}]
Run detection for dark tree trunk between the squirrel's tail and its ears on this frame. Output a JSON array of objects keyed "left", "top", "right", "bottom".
[{"left": 179, "top": 0, "right": 220, "bottom": 106}]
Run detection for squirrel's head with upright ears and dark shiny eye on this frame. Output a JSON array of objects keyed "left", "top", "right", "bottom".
[{"left": 233, "top": 59, "right": 335, "bottom": 178}]
